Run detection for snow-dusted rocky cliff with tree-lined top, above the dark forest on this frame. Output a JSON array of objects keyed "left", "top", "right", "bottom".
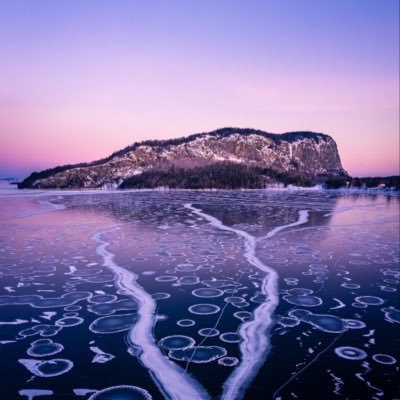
[{"left": 20, "top": 128, "right": 347, "bottom": 189}]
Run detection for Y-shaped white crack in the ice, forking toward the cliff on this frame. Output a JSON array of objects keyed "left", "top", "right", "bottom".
[{"left": 185, "top": 204, "right": 308, "bottom": 400}]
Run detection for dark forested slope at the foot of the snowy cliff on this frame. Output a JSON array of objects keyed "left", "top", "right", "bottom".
[{"left": 120, "top": 162, "right": 314, "bottom": 189}]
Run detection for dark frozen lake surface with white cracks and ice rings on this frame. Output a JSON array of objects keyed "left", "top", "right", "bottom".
[{"left": 0, "top": 191, "right": 400, "bottom": 400}]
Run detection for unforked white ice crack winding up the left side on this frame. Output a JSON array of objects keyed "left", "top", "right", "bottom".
[{"left": 91, "top": 227, "right": 209, "bottom": 400}]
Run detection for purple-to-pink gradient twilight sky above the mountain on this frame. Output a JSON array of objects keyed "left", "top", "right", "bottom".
[{"left": 0, "top": 0, "right": 400, "bottom": 177}]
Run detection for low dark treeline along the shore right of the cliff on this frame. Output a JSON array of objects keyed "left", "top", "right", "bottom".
[{"left": 324, "top": 176, "right": 400, "bottom": 190}]
